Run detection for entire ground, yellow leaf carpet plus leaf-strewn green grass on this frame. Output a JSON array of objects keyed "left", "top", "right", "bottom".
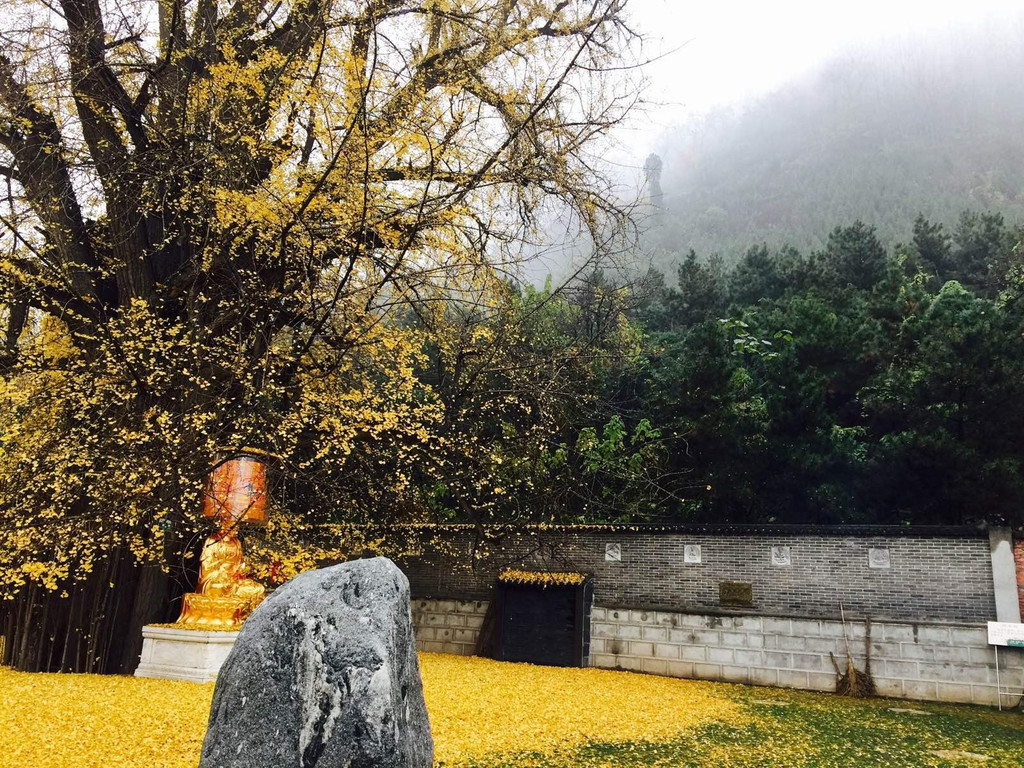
[{"left": 0, "top": 653, "right": 1024, "bottom": 768}]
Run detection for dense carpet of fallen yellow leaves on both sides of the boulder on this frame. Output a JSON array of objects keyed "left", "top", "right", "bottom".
[{"left": 0, "top": 653, "right": 739, "bottom": 768}]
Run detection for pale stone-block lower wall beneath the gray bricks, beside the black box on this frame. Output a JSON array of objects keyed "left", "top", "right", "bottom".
[{"left": 413, "top": 600, "right": 1024, "bottom": 707}]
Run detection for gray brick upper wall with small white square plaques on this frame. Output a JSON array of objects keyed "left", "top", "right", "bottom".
[{"left": 402, "top": 528, "right": 995, "bottom": 624}]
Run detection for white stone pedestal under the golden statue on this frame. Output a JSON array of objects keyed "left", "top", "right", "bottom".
[{"left": 135, "top": 625, "right": 239, "bottom": 683}]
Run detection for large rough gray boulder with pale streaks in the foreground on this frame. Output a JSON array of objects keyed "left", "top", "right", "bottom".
[{"left": 200, "top": 557, "right": 434, "bottom": 768}]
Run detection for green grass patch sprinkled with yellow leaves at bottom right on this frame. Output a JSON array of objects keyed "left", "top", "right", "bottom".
[{"left": 456, "top": 686, "right": 1024, "bottom": 768}]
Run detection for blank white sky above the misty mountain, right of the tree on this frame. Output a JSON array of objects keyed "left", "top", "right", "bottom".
[{"left": 618, "top": 0, "right": 1024, "bottom": 165}]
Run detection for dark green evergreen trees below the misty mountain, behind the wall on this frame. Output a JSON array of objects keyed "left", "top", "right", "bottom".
[{"left": 602, "top": 212, "right": 1024, "bottom": 524}]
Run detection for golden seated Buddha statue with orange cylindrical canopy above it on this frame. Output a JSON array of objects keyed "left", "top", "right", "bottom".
[{"left": 177, "top": 451, "right": 266, "bottom": 629}]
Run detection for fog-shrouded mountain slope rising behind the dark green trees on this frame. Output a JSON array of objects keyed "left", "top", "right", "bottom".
[{"left": 648, "top": 15, "right": 1024, "bottom": 267}]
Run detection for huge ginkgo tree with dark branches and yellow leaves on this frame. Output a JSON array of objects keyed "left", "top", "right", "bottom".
[{"left": 0, "top": 0, "right": 636, "bottom": 667}]
